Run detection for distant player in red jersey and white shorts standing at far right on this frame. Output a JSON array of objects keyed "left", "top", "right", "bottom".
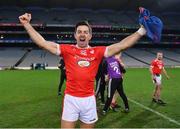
[{"left": 150, "top": 52, "right": 169, "bottom": 105}]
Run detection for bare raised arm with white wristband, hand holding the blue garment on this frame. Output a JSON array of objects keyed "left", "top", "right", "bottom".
[{"left": 105, "top": 27, "right": 146, "bottom": 57}]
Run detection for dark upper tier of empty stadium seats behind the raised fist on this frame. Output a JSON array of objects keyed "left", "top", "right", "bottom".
[{"left": 0, "top": 6, "right": 180, "bottom": 26}]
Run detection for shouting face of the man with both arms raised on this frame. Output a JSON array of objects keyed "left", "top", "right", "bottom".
[{"left": 74, "top": 25, "right": 92, "bottom": 48}]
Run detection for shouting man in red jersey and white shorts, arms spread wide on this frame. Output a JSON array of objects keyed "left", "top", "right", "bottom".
[{"left": 19, "top": 13, "right": 146, "bottom": 128}]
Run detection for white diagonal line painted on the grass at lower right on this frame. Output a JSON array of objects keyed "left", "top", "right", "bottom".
[{"left": 128, "top": 98, "right": 180, "bottom": 125}]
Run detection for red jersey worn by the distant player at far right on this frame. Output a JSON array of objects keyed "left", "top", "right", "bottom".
[{"left": 151, "top": 59, "right": 164, "bottom": 74}]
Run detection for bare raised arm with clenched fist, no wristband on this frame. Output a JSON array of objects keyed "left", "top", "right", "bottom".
[{"left": 19, "top": 13, "right": 58, "bottom": 54}]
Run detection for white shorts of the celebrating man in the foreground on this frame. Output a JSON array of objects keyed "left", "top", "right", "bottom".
[{"left": 62, "top": 94, "right": 98, "bottom": 124}]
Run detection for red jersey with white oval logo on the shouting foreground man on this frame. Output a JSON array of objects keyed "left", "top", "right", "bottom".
[{"left": 59, "top": 44, "right": 106, "bottom": 97}]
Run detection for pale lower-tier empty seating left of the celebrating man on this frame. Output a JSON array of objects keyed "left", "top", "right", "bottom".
[{"left": 0, "top": 47, "right": 58, "bottom": 68}]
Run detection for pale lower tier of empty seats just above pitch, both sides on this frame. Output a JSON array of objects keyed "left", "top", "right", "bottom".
[{"left": 0, "top": 47, "right": 180, "bottom": 67}]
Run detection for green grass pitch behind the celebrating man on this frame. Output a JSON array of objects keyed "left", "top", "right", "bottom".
[{"left": 0, "top": 68, "right": 180, "bottom": 128}]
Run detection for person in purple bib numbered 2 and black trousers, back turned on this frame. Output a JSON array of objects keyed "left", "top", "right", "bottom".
[{"left": 103, "top": 53, "right": 129, "bottom": 115}]
